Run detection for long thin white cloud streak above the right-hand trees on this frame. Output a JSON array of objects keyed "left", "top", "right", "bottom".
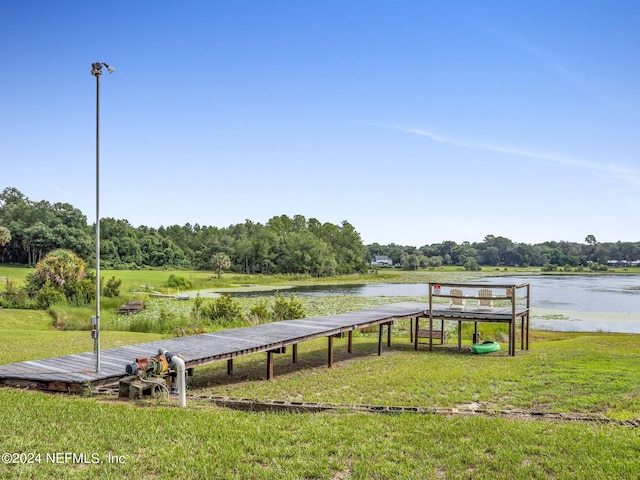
[{"left": 395, "top": 126, "right": 640, "bottom": 188}]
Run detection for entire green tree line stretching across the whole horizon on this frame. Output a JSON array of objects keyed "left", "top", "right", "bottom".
[{"left": 0, "top": 187, "right": 640, "bottom": 277}]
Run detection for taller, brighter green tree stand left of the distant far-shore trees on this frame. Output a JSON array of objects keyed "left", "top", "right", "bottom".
[{"left": 0, "top": 187, "right": 368, "bottom": 277}]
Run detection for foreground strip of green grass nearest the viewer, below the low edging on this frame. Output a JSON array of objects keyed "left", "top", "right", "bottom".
[{"left": 0, "top": 390, "right": 640, "bottom": 480}]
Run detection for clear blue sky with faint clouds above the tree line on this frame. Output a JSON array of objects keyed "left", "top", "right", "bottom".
[{"left": 0, "top": 0, "right": 640, "bottom": 246}]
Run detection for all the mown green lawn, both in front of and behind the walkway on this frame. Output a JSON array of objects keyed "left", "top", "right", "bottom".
[{"left": 0, "top": 304, "right": 640, "bottom": 479}]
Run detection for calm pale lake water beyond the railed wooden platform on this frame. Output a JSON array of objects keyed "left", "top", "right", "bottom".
[{"left": 288, "top": 275, "right": 640, "bottom": 333}]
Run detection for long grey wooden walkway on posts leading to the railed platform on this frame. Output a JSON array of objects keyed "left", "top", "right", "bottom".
[{"left": 0, "top": 302, "right": 429, "bottom": 392}]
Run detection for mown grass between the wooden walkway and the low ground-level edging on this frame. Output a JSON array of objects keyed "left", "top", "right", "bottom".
[{"left": 186, "top": 332, "right": 640, "bottom": 420}]
